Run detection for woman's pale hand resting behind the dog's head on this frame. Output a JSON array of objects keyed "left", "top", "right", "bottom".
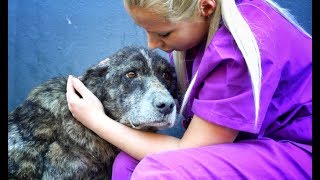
[{"left": 66, "top": 75, "right": 106, "bottom": 129}]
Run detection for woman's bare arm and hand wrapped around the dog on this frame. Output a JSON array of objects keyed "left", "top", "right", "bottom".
[{"left": 66, "top": 77, "right": 238, "bottom": 160}]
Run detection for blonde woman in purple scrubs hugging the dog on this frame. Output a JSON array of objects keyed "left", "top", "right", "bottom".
[{"left": 67, "top": 0, "right": 312, "bottom": 180}]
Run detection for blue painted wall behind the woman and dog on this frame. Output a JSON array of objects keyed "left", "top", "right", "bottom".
[{"left": 8, "top": 0, "right": 312, "bottom": 138}]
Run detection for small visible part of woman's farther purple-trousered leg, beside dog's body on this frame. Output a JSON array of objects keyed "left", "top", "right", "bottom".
[{"left": 112, "top": 151, "right": 139, "bottom": 180}]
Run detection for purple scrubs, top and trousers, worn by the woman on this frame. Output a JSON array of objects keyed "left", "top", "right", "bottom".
[{"left": 113, "top": 0, "right": 312, "bottom": 180}]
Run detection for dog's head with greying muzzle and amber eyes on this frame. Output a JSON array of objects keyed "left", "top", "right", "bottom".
[{"left": 80, "top": 46, "right": 177, "bottom": 129}]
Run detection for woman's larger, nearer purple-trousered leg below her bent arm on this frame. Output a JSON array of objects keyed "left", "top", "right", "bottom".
[{"left": 131, "top": 138, "right": 312, "bottom": 180}]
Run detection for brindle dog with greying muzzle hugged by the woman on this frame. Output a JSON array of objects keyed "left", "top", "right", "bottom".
[{"left": 8, "top": 46, "right": 178, "bottom": 179}]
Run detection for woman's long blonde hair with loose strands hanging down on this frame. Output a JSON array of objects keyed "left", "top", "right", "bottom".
[{"left": 124, "top": 0, "right": 310, "bottom": 128}]
